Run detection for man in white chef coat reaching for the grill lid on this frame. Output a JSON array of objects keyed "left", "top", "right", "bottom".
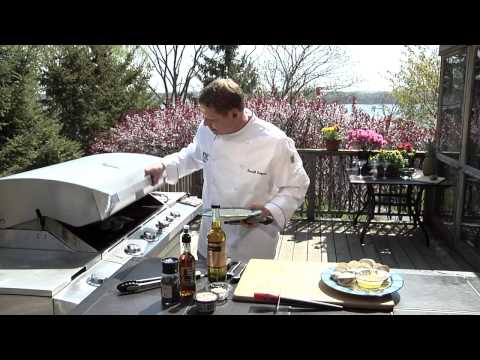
[{"left": 145, "top": 79, "right": 310, "bottom": 261}]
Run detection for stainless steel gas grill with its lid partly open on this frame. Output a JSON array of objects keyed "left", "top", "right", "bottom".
[{"left": 0, "top": 153, "right": 201, "bottom": 314}]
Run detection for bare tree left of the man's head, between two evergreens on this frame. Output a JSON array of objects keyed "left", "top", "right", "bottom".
[{"left": 146, "top": 45, "right": 207, "bottom": 104}]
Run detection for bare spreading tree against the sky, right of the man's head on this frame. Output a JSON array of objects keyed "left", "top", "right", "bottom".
[{"left": 264, "top": 45, "right": 354, "bottom": 98}]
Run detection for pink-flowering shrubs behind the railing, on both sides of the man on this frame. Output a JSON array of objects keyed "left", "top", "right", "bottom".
[{"left": 89, "top": 96, "right": 434, "bottom": 156}]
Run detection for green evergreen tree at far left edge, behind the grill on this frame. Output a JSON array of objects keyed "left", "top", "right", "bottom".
[{"left": 0, "top": 46, "right": 81, "bottom": 176}]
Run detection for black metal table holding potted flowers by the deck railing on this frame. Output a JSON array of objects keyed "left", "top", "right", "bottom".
[{"left": 349, "top": 170, "right": 450, "bottom": 246}]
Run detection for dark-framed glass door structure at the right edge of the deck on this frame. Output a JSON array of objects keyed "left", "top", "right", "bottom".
[{"left": 436, "top": 46, "right": 480, "bottom": 259}]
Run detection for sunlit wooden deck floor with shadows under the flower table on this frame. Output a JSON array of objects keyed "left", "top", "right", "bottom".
[{"left": 276, "top": 220, "right": 479, "bottom": 271}]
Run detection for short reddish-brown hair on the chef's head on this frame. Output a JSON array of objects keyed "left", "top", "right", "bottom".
[{"left": 198, "top": 79, "right": 245, "bottom": 114}]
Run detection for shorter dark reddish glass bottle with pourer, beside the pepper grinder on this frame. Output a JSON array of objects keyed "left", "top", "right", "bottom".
[{"left": 178, "top": 225, "right": 195, "bottom": 301}]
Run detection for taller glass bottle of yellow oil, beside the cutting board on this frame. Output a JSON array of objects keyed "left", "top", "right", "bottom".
[{"left": 207, "top": 205, "right": 227, "bottom": 282}]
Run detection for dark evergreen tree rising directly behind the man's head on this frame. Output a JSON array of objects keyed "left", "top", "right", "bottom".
[{"left": 199, "top": 45, "right": 259, "bottom": 94}]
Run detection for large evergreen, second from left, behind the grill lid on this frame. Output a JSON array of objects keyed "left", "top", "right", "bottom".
[{"left": 41, "top": 45, "right": 154, "bottom": 150}]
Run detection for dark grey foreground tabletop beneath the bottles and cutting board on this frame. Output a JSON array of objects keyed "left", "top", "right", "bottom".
[{"left": 71, "top": 258, "right": 480, "bottom": 315}]
